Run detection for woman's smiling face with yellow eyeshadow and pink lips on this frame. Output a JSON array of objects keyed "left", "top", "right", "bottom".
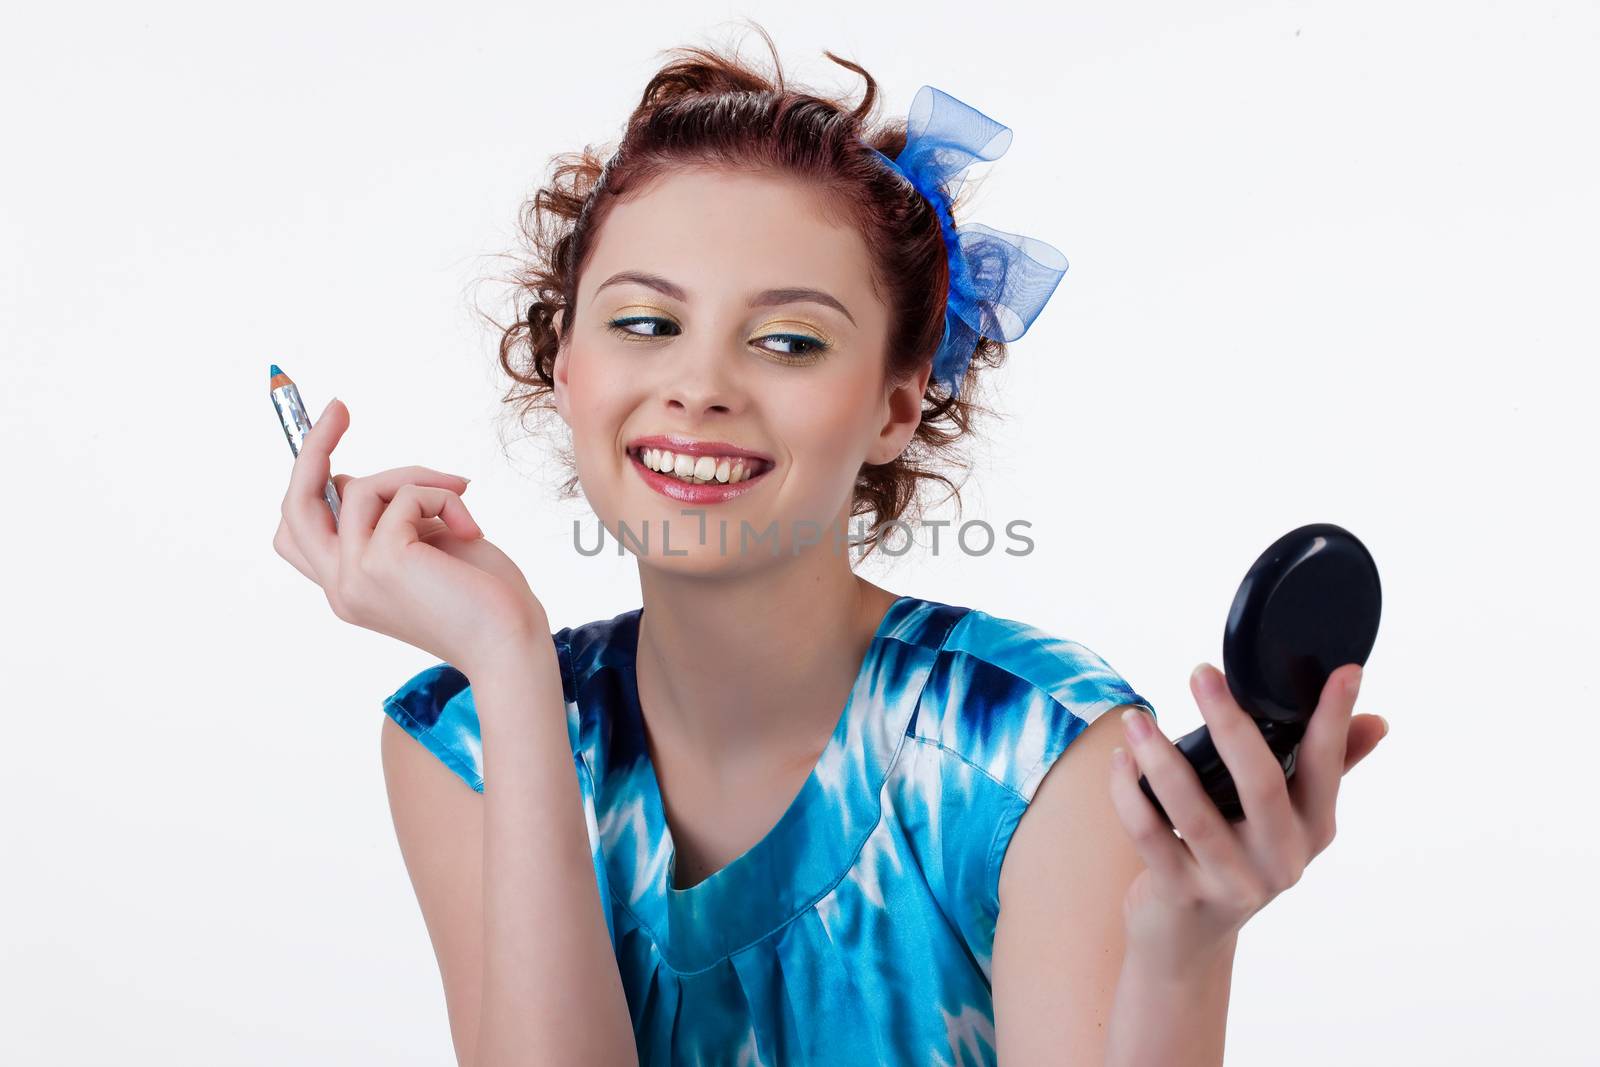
[{"left": 555, "top": 168, "right": 926, "bottom": 571}]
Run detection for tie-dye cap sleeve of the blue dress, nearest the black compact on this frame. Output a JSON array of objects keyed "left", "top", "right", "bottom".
[{"left": 910, "top": 608, "right": 1155, "bottom": 800}]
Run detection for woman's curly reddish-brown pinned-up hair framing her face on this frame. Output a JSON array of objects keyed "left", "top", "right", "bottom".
[{"left": 494, "top": 26, "right": 1006, "bottom": 553}]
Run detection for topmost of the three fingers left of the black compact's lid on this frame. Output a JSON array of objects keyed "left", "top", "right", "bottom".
[{"left": 1189, "top": 664, "right": 1298, "bottom": 861}]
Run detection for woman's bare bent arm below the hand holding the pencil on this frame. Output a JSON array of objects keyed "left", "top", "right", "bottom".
[{"left": 382, "top": 617, "right": 638, "bottom": 1067}]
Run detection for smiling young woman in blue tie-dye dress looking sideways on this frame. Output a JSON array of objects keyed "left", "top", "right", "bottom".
[{"left": 275, "top": 24, "right": 1382, "bottom": 1067}]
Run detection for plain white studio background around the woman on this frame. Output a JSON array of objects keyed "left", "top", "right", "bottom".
[{"left": 0, "top": 0, "right": 1600, "bottom": 1065}]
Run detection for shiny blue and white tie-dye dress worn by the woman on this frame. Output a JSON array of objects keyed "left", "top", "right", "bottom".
[{"left": 384, "top": 597, "right": 1154, "bottom": 1067}]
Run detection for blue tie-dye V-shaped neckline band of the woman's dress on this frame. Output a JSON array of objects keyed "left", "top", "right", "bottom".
[{"left": 603, "top": 595, "right": 952, "bottom": 973}]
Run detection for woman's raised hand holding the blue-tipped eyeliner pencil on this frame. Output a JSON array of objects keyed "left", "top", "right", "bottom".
[{"left": 272, "top": 400, "right": 546, "bottom": 677}]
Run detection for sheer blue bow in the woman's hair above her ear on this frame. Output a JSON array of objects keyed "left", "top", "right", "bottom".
[{"left": 870, "top": 85, "right": 1067, "bottom": 395}]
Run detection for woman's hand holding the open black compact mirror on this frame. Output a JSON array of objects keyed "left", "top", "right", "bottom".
[{"left": 1110, "top": 664, "right": 1389, "bottom": 981}]
